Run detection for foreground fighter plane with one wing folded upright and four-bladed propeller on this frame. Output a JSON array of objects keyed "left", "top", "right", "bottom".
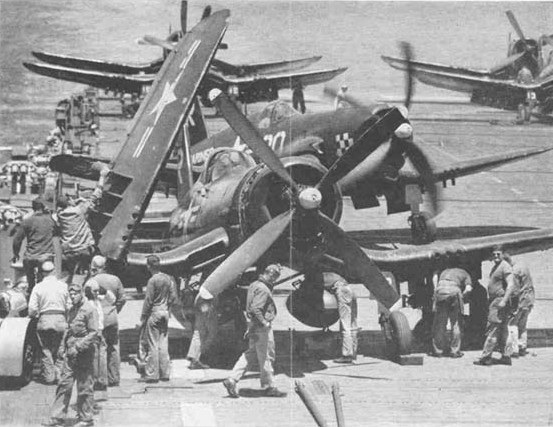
[{"left": 31, "top": 6, "right": 553, "bottom": 376}]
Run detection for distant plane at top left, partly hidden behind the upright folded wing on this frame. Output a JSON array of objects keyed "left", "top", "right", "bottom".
[{"left": 23, "top": 1, "right": 347, "bottom": 106}]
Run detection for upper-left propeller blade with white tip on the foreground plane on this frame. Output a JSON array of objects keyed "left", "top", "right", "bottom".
[{"left": 209, "top": 89, "right": 298, "bottom": 192}]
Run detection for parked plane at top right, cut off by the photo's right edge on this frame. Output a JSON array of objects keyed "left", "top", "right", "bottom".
[{"left": 382, "top": 11, "right": 553, "bottom": 120}]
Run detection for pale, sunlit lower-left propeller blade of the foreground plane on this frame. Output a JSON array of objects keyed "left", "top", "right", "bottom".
[{"left": 198, "top": 210, "right": 294, "bottom": 299}]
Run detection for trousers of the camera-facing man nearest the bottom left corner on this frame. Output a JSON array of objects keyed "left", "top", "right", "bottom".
[{"left": 50, "top": 350, "right": 94, "bottom": 421}]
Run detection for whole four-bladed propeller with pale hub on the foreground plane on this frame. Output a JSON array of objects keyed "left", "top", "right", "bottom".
[{"left": 199, "top": 90, "right": 420, "bottom": 308}]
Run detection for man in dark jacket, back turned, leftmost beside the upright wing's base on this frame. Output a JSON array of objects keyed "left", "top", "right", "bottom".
[{"left": 12, "top": 197, "right": 57, "bottom": 292}]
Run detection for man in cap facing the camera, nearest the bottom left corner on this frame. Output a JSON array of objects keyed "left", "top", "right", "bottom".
[{"left": 46, "top": 284, "right": 98, "bottom": 427}]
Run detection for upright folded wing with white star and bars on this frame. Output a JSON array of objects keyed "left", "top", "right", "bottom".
[{"left": 98, "top": 10, "right": 230, "bottom": 258}]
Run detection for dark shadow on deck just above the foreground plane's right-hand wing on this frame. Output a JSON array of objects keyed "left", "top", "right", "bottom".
[{"left": 347, "top": 225, "right": 535, "bottom": 251}]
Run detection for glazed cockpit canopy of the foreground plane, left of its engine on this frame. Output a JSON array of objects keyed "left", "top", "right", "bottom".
[{"left": 200, "top": 147, "right": 255, "bottom": 184}]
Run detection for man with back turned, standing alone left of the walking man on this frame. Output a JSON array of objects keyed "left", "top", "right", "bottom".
[{"left": 141, "top": 255, "right": 177, "bottom": 383}]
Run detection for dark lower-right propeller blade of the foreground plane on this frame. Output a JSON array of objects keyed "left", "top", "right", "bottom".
[{"left": 319, "top": 213, "right": 399, "bottom": 309}]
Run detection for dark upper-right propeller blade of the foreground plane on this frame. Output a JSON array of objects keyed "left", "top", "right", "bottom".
[{"left": 317, "top": 108, "right": 406, "bottom": 188}]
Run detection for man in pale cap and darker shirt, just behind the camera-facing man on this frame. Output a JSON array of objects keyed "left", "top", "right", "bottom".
[{"left": 87, "top": 255, "right": 126, "bottom": 387}]
